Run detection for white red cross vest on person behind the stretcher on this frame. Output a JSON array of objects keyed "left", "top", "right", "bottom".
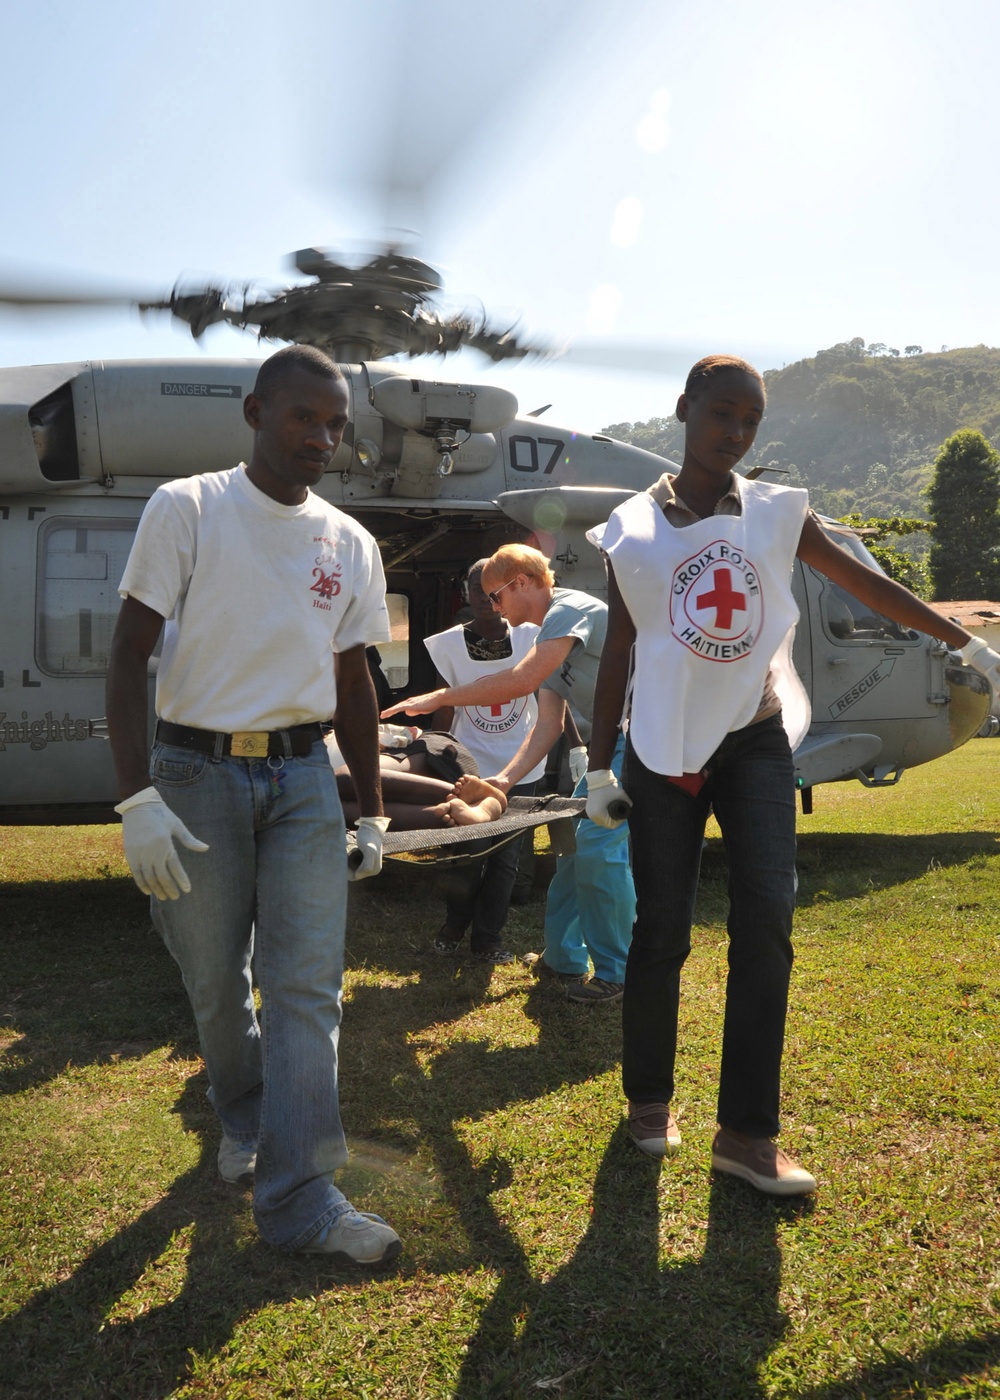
[{"left": 424, "top": 622, "right": 545, "bottom": 783}]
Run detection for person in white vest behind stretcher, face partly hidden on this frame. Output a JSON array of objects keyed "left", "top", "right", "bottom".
[{"left": 424, "top": 559, "right": 545, "bottom": 963}]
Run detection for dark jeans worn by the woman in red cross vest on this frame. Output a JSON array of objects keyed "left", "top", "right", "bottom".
[{"left": 622, "top": 715, "right": 796, "bottom": 1137}]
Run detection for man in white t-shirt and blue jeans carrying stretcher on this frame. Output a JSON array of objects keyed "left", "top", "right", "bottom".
[{"left": 108, "top": 346, "right": 402, "bottom": 1266}]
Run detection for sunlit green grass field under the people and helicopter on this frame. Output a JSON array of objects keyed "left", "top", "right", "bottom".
[{"left": 0, "top": 739, "right": 1000, "bottom": 1400}]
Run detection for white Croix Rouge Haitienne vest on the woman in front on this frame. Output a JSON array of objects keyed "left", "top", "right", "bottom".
[{"left": 588, "top": 480, "right": 810, "bottom": 776}]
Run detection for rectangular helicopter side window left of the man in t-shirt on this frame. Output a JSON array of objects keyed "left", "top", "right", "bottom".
[{"left": 35, "top": 517, "right": 137, "bottom": 676}]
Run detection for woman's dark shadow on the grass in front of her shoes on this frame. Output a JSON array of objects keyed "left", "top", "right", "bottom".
[{"left": 454, "top": 1124, "right": 811, "bottom": 1400}]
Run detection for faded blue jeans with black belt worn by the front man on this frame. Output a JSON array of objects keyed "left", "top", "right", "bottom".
[{"left": 150, "top": 742, "right": 349, "bottom": 1249}]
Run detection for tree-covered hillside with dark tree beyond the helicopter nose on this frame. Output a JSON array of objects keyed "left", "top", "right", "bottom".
[{"left": 604, "top": 336, "right": 1000, "bottom": 601}]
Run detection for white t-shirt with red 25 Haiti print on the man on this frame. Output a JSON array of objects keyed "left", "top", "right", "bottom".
[{"left": 118, "top": 463, "right": 389, "bottom": 734}]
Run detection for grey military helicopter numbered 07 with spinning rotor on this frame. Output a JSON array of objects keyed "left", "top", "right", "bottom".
[{"left": 0, "top": 248, "right": 992, "bottom": 825}]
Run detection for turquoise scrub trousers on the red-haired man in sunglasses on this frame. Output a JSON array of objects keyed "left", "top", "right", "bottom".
[{"left": 545, "top": 735, "right": 636, "bottom": 983}]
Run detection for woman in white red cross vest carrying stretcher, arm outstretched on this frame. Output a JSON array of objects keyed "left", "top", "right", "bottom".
[{"left": 587, "top": 356, "right": 1000, "bottom": 1196}]
